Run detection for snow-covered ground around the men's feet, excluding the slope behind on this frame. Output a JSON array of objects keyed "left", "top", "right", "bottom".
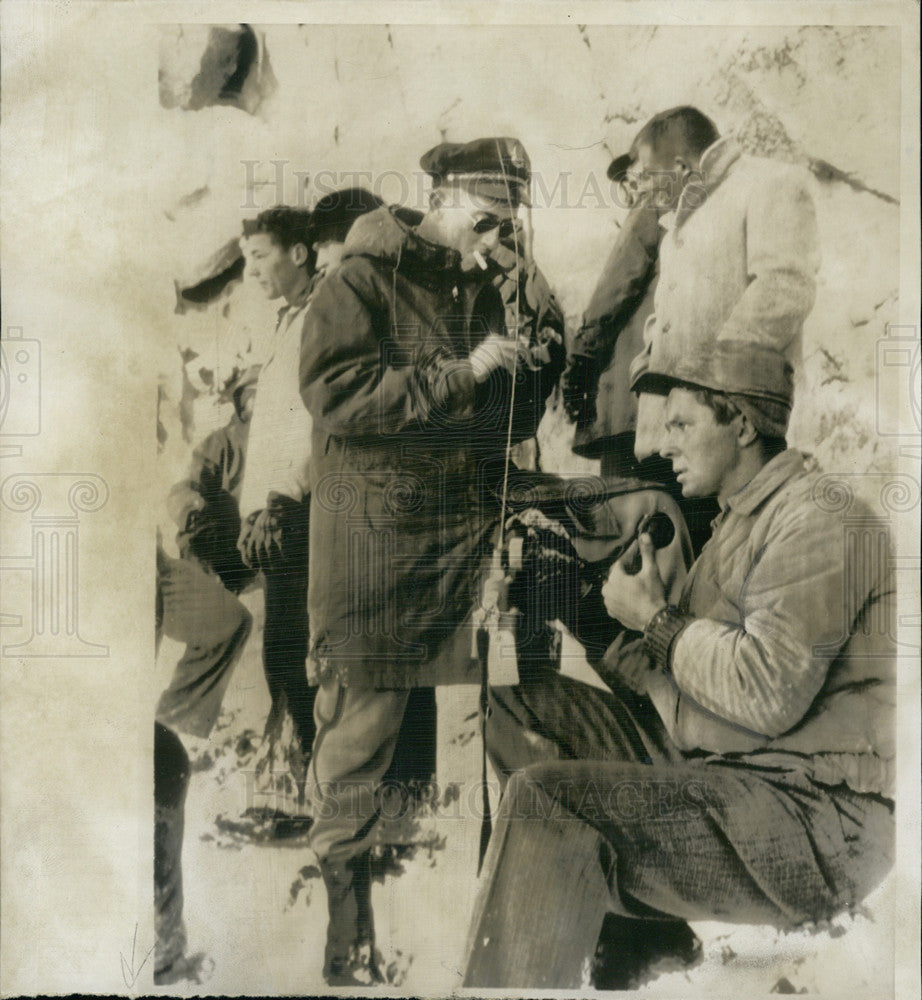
[{"left": 161, "top": 608, "right": 895, "bottom": 1000}]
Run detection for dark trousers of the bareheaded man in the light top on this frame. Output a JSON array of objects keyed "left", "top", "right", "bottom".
[{"left": 263, "top": 568, "right": 316, "bottom": 752}]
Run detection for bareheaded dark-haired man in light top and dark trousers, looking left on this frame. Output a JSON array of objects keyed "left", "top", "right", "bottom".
[{"left": 237, "top": 205, "right": 314, "bottom": 794}]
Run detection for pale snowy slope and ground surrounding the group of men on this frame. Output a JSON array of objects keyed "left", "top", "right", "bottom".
[{"left": 142, "top": 24, "right": 904, "bottom": 1000}]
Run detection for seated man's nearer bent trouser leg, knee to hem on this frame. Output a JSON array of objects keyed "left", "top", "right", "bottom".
[{"left": 466, "top": 762, "right": 893, "bottom": 988}]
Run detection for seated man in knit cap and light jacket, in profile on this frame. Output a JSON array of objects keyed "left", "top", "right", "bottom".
[{"left": 465, "top": 341, "right": 894, "bottom": 989}]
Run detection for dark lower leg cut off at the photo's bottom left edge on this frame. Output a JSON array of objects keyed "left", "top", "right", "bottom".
[{"left": 154, "top": 722, "right": 189, "bottom": 978}]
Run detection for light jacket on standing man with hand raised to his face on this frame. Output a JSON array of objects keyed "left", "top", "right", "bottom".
[{"left": 631, "top": 138, "right": 820, "bottom": 459}]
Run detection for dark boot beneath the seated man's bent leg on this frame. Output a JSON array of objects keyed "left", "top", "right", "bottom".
[{"left": 592, "top": 913, "right": 701, "bottom": 990}]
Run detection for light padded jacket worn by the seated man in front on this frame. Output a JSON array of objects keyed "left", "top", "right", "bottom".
[{"left": 647, "top": 450, "right": 895, "bottom": 795}]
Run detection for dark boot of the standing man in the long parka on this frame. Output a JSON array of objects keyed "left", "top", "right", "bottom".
[{"left": 320, "top": 851, "right": 384, "bottom": 986}]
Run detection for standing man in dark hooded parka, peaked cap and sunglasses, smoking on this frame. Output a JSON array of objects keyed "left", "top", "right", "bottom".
[{"left": 301, "top": 138, "right": 556, "bottom": 985}]
